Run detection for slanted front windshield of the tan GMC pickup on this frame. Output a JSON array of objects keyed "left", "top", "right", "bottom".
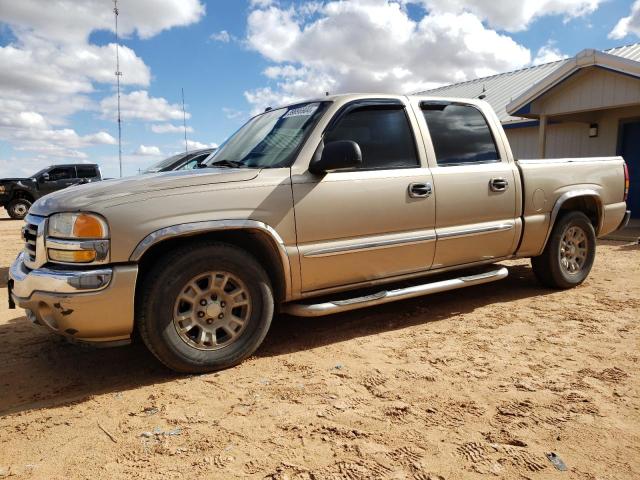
[{"left": 205, "top": 102, "right": 327, "bottom": 168}]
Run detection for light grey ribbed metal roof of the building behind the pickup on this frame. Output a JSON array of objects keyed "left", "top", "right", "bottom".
[{"left": 419, "top": 43, "right": 640, "bottom": 123}]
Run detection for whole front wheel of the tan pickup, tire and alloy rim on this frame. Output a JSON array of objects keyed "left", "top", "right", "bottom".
[{"left": 136, "top": 242, "right": 274, "bottom": 373}]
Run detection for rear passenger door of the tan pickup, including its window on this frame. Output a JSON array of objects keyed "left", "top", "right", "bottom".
[{"left": 417, "top": 101, "right": 520, "bottom": 268}]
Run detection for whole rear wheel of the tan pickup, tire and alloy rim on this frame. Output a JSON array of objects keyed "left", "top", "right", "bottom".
[{"left": 531, "top": 212, "right": 596, "bottom": 289}]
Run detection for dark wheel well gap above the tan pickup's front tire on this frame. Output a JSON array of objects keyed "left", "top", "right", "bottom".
[{"left": 136, "top": 229, "right": 286, "bottom": 304}]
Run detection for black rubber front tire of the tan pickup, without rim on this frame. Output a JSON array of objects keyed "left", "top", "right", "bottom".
[{"left": 136, "top": 242, "right": 274, "bottom": 373}]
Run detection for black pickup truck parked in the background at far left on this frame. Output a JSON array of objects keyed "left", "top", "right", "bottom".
[{"left": 0, "top": 163, "right": 102, "bottom": 220}]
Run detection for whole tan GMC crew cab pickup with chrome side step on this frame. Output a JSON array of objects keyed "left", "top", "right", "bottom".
[{"left": 8, "top": 95, "right": 629, "bottom": 372}]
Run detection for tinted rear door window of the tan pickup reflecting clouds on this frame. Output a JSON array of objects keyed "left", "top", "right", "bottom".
[{"left": 421, "top": 103, "right": 500, "bottom": 166}]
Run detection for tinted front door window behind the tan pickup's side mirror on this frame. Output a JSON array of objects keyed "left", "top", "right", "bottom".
[{"left": 324, "top": 105, "right": 419, "bottom": 170}]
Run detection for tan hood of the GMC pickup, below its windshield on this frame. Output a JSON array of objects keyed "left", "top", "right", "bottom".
[{"left": 30, "top": 168, "right": 260, "bottom": 216}]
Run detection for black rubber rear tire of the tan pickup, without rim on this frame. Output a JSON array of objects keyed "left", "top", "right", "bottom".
[{"left": 531, "top": 212, "right": 596, "bottom": 289}]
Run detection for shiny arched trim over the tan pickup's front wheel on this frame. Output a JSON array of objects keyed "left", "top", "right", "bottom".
[{"left": 129, "top": 220, "right": 291, "bottom": 298}]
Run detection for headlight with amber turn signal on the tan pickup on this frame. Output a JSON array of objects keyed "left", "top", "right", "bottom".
[{"left": 45, "top": 213, "right": 109, "bottom": 263}]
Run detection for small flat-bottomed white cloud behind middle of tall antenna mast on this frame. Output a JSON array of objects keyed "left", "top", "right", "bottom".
[{"left": 100, "top": 90, "right": 190, "bottom": 122}]
